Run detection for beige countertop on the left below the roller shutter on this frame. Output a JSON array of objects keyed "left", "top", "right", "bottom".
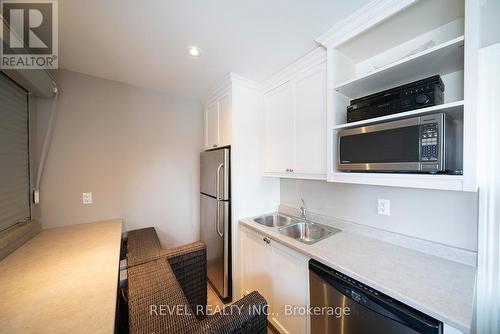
[{"left": 0, "top": 219, "right": 122, "bottom": 334}]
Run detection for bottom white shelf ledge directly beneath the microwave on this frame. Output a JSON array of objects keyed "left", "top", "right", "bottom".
[{"left": 328, "top": 172, "right": 464, "bottom": 191}]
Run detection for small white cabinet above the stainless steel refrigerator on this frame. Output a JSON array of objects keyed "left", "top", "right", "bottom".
[{"left": 205, "top": 92, "right": 231, "bottom": 150}]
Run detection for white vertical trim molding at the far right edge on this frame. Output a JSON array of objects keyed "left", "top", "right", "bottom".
[{"left": 473, "top": 43, "right": 500, "bottom": 333}]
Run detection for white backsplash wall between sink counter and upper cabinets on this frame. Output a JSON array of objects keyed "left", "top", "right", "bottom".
[{"left": 281, "top": 179, "right": 478, "bottom": 251}]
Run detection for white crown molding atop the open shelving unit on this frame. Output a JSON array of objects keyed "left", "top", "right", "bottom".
[{"left": 315, "top": 0, "right": 418, "bottom": 48}]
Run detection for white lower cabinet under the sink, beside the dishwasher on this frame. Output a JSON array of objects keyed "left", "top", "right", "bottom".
[{"left": 241, "top": 228, "right": 309, "bottom": 334}]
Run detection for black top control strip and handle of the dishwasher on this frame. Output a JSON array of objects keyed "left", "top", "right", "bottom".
[{"left": 309, "top": 260, "right": 442, "bottom": 334}]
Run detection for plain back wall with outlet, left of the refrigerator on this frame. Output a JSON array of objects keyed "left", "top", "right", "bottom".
[{"left": 33, "top": 71, "right": 203, "bottom": 245}]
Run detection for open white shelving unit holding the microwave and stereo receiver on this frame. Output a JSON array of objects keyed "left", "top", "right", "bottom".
[{"left": 324, "top": 0, "right": 480, "bottom": 191}]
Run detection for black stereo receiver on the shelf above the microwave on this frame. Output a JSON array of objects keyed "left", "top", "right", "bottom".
[{"left": 347, "top": 75, "right": 444, "bottom": 123}]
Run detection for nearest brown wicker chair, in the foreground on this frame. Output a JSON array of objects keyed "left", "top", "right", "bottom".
[{"left": 128, "top": 236, "right": 267, "bottom": 334}]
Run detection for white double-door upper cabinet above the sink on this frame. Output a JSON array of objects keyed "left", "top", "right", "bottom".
[{"left": 264, "top": 49, "right": 327, "bottom": 180}]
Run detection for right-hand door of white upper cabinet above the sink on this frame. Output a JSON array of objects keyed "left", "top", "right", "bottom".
[{"left": 293, "top": 63, "right": 326, "bottom": 174}]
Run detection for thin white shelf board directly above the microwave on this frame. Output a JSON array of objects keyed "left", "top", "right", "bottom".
[{"left": 333, "top": 100, "right": 464, "bottom": 130}]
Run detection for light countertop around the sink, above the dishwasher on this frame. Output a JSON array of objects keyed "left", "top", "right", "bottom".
[{"left": 240, "top": 218, "right": 476, "bottom": 333}]
